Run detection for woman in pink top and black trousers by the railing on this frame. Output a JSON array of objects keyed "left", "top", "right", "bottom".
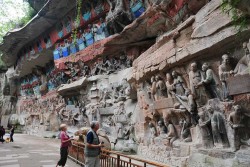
[{"left": 56, "top": 124, "right": 73, "bottom": 167}]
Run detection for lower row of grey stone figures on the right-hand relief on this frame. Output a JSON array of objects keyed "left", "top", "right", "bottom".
[{"left": 149, "top": 102, "right": 250, "bottom": 151}]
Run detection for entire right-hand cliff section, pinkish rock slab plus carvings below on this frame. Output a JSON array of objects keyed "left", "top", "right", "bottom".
[{"left": 132, "top": 0, "right": 250, "bottom": 167}]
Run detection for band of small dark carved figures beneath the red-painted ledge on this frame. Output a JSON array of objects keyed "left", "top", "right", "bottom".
[{"left": 21, "top": 57, "right": 131, "bottom": 93}]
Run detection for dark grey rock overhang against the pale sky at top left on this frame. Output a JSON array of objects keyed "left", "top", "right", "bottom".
[{"left": 0, "top": 0, "right": 75, "bottom": 66}]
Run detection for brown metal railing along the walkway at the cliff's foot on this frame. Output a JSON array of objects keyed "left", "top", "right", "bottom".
[{"left": 69, "top": 142, "right": 168, "bottom": 167}]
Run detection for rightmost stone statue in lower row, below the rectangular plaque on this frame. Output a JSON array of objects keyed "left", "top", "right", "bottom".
[{"left": 228, "top": 105, "right": 247, "bottom": 151}]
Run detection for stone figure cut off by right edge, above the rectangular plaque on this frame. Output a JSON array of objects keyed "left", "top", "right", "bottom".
[{"left": 234, "top": 39, "right": 250, "bottom": 75}]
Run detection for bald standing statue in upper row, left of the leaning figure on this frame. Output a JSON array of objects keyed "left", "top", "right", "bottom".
[{"left": 189, "top": 62, "right": 208, "bottom": 106}]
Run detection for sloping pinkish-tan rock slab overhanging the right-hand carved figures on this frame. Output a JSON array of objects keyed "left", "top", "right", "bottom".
[{"left": 133, "top": 0, "right": 250, "bottom": 80}]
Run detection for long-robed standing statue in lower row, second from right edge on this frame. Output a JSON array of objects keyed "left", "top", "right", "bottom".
[{"left": 207, "top": 105, "right": 229, "bottom": 148}]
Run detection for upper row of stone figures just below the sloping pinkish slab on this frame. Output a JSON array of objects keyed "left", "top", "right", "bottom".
[{"left": 148, "top": 54, "right": 250, "bottom": 108}]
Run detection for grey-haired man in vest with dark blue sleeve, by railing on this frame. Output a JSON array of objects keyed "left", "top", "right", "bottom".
[{"left": 85, "top": 121, "right": 104, "bottom": 167}]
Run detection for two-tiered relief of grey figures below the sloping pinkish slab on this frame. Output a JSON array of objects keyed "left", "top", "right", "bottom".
[{"left": 135, "top": 38, "right": 250, "bottom": 165}]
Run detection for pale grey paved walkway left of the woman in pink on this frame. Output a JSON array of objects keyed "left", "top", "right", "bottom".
[{"left": 0, "top": 134, "right": 80, "bottom": 167}]
